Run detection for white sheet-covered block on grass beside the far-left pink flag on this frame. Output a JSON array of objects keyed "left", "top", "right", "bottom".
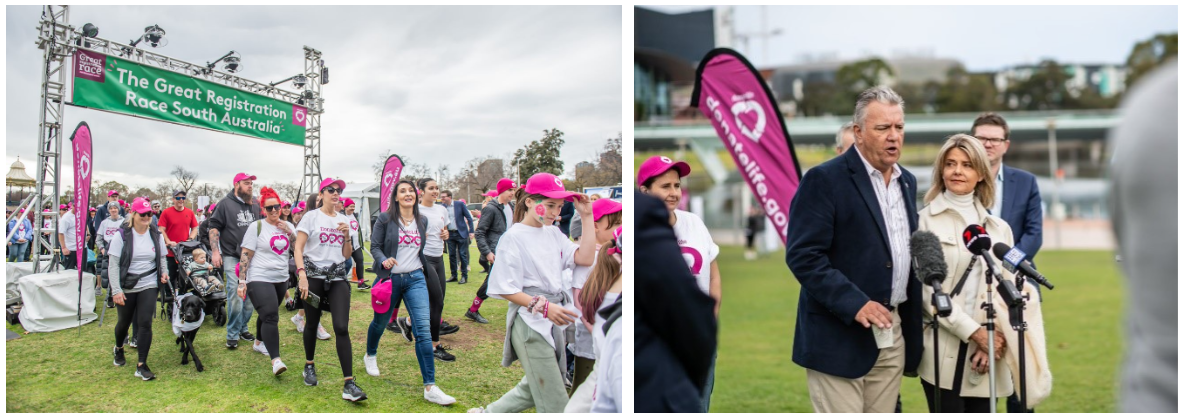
[{"left": 18, "top": 269, "right": 98, "bottom": 332}]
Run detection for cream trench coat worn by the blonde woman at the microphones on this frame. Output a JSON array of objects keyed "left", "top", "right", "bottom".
[{"left": 918, "top": 195, "right": 1052, "bottom": 408}]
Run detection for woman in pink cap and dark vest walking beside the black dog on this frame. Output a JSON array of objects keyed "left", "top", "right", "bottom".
[{"left": 107, "top": 197, "right": 168, "bottom": 381}]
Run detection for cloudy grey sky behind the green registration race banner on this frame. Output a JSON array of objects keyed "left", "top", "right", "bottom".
[{"left": 5, "top": 6, "right": 623, "bottom": 192}]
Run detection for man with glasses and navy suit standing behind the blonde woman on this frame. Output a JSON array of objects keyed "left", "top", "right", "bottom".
[{"left": 971, "top": 113, "right": 1042, "bottom": 413}]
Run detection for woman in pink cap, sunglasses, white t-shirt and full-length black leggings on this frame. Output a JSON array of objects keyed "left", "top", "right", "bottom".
[{"left": 293, "top": 178, "right": 366, "bottom": 401}]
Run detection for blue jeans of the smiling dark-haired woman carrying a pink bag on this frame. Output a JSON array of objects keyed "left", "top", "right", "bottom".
[{"left": 366, "top": 269, "right": 436, "bottom": 386}]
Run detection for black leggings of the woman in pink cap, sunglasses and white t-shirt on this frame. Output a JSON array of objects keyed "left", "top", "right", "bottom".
[{"left": 304, "top": 279, "right": 355, "bottom": 377}]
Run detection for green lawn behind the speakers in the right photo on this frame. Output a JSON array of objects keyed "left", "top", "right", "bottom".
[{"left": 712, "top": 247, "right": 1124, "bottom": 413}]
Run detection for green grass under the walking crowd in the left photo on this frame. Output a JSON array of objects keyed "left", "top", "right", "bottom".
[{"left": 5, "top": 247, "right": 523, "bottom": 413}]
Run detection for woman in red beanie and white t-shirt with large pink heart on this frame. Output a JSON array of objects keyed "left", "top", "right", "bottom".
[{"left": 238, "top": 186, "right": 297, "bottom": 375}]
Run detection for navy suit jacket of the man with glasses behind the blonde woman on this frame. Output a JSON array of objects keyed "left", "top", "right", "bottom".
[{"left": 997, "top": 164, "right": 1041, "bottom": 263}]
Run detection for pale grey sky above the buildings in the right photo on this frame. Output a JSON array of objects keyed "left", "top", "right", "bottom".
[{"left": 646, "top": 6, "right": 1178, "bottom": 71}]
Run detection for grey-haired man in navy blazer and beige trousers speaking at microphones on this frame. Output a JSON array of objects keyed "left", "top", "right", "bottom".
[{"left": 786, "top": 87, "right": 923, "bottom": 413}]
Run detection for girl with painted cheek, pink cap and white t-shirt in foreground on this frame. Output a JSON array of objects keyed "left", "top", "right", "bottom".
[{"left": 471, "top": 173, "right": 597, "bottom": 413}]
